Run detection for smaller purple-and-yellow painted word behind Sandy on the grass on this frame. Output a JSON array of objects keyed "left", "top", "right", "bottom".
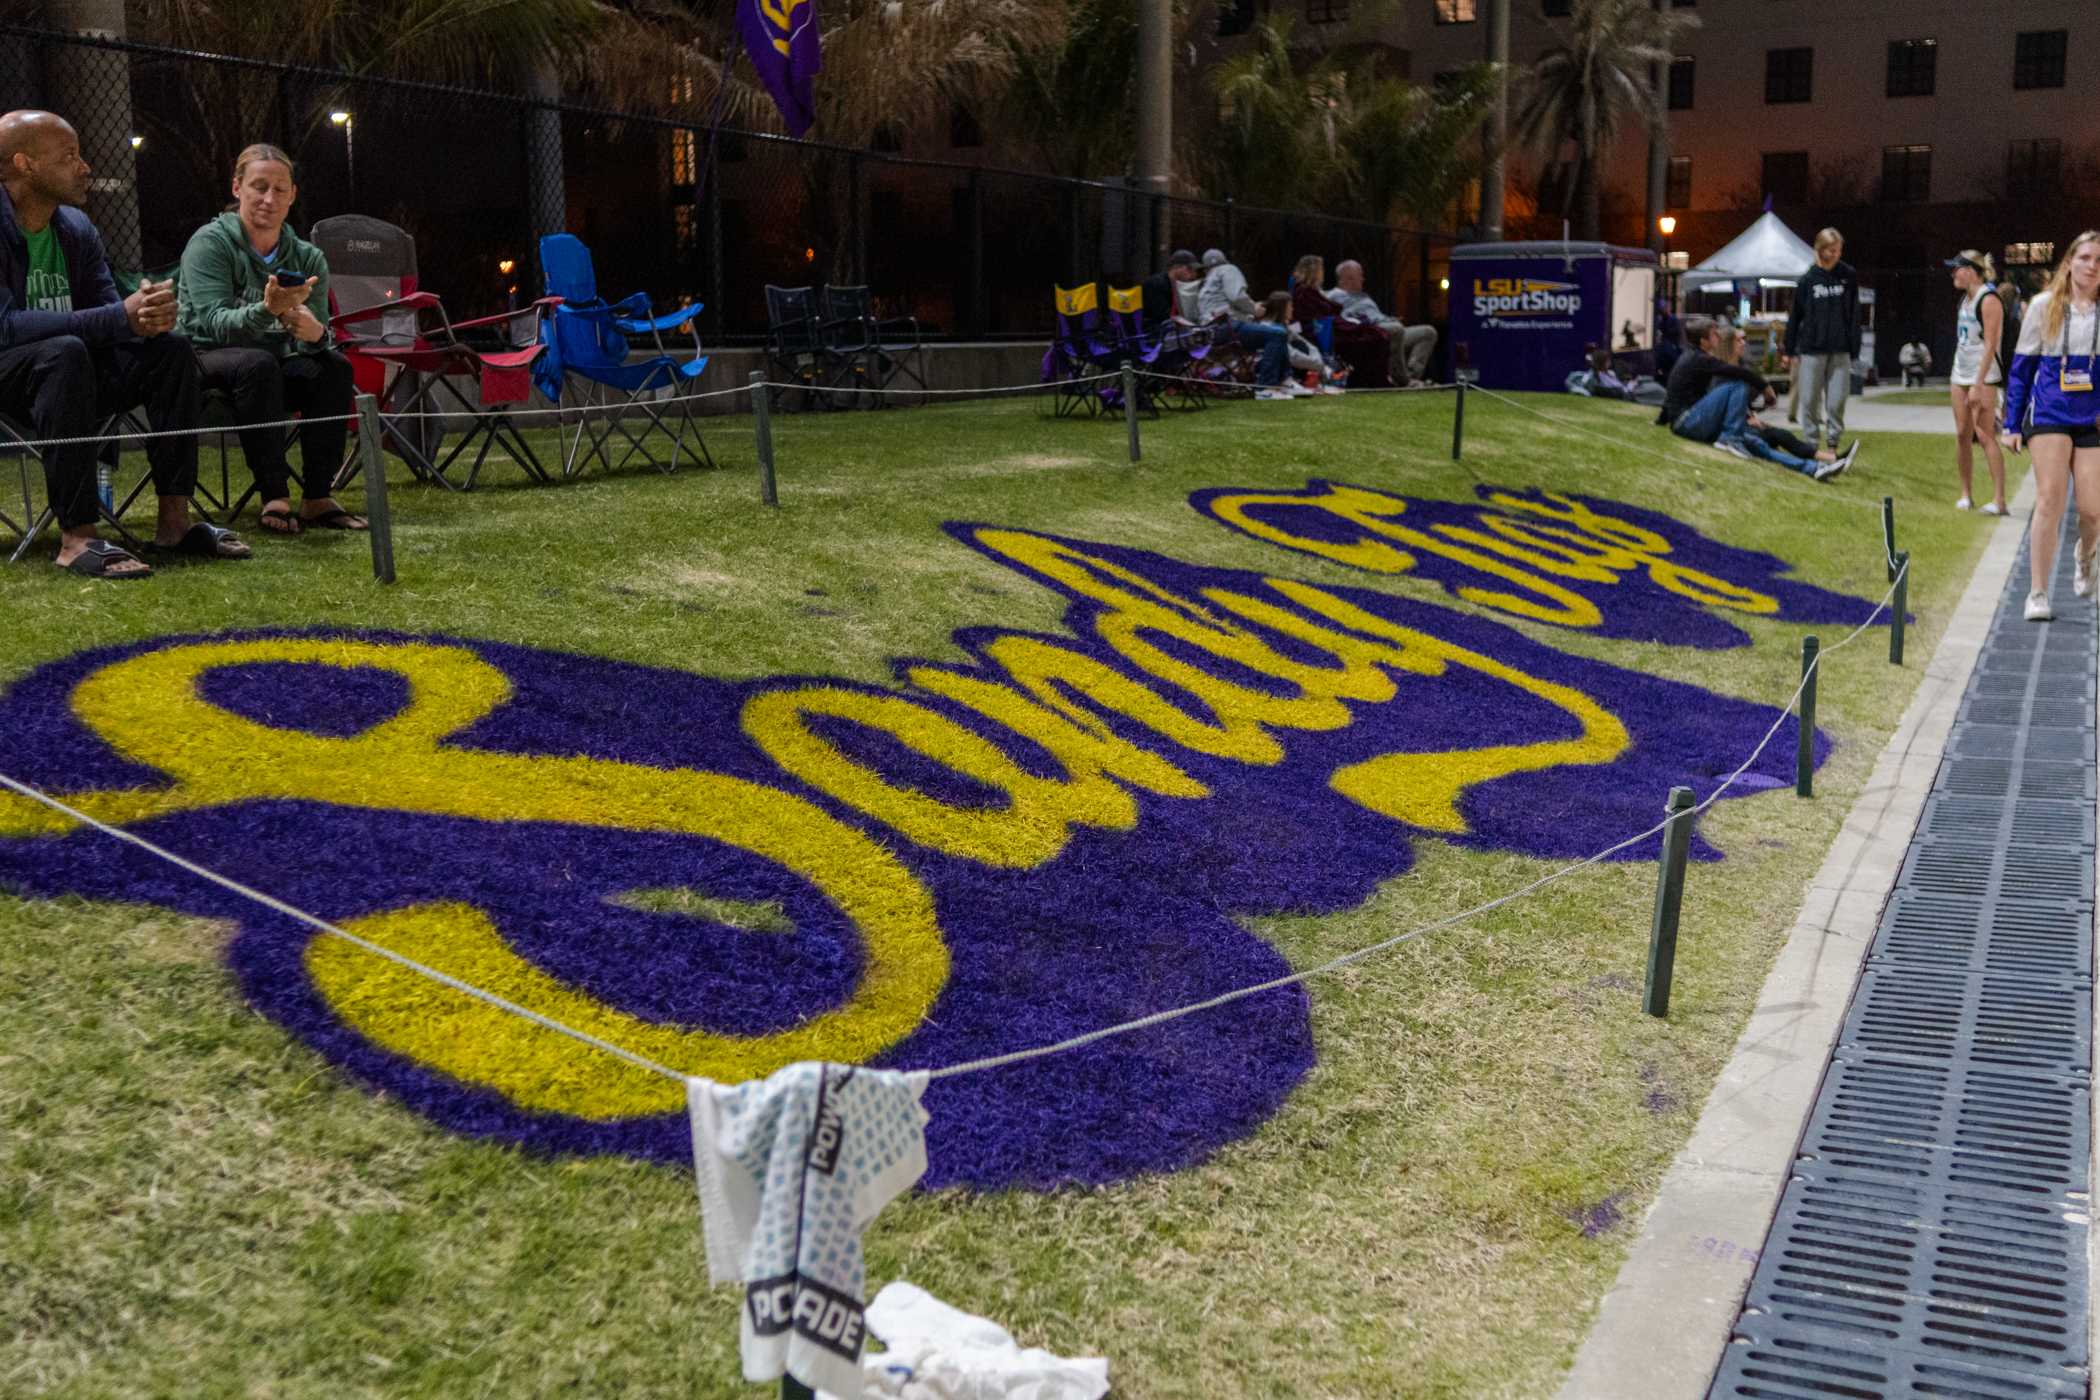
[{"left": 1189, "top": 479, "right": 1886, "bottom": 649}]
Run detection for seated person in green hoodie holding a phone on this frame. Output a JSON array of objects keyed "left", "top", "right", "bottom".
[{"left": 176, "top": 145, "right": 365, "bottom": 535}]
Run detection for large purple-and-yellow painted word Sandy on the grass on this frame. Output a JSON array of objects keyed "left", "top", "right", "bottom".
[{"left": 0, "top": 525, "right": 1827, "bottom": 1188}]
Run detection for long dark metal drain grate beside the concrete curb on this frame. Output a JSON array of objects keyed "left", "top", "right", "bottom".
[{"left": 1709, "top": 528, "right": 2100, "bottom": 1400}]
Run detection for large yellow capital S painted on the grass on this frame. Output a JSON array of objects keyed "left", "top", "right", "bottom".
[{"left": 0, "top": 638, "right": 947, "bottom": 1119}]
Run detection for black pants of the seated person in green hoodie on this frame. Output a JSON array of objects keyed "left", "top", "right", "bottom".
[{"left": 197, "top": 344, "right": 353, "bottom": 502}]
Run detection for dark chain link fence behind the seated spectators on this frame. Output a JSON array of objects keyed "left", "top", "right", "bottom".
[{"left": 0, "top": 25, "right": 1453, "bottom": 342}]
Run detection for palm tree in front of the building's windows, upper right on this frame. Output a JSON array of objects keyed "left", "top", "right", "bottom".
[{"left": 1516, "top": 0, "right": 1699, "bottom": 239}]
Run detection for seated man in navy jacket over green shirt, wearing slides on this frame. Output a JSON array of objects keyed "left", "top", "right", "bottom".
[{"left": 0, "top": 111, "right": 248, "bottom": 579}]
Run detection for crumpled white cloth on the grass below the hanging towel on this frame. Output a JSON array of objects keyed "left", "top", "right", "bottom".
[{"left": 817, "top": 1280, "right": 1109, "bottom": 1400}]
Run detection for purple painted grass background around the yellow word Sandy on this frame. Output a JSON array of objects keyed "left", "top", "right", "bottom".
[{"left": 0, "top": 521, "right": 1829, "bottom": 1188}]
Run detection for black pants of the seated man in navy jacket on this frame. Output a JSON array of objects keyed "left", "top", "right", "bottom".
[{"left": 0, "top": 336, "right": 202, "bottom": 529}]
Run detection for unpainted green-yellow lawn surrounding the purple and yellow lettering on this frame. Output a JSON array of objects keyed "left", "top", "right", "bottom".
[{"left": 0, "top": 395, "right": 2012, "bottom": 1400}]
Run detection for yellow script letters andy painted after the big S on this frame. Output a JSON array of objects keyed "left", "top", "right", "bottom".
[{"left": 743, "top": 529, "right": 1628, "bottom": 867}]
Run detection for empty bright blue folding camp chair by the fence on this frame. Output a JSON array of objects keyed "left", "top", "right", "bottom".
[{"left": 533, "top": 233, "right": 714, "bottom": 476}]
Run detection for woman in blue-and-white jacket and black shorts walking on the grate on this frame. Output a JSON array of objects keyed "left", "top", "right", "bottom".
[{"left": 1993, "top": 229, "right": 2100, "bottom": 621}]
